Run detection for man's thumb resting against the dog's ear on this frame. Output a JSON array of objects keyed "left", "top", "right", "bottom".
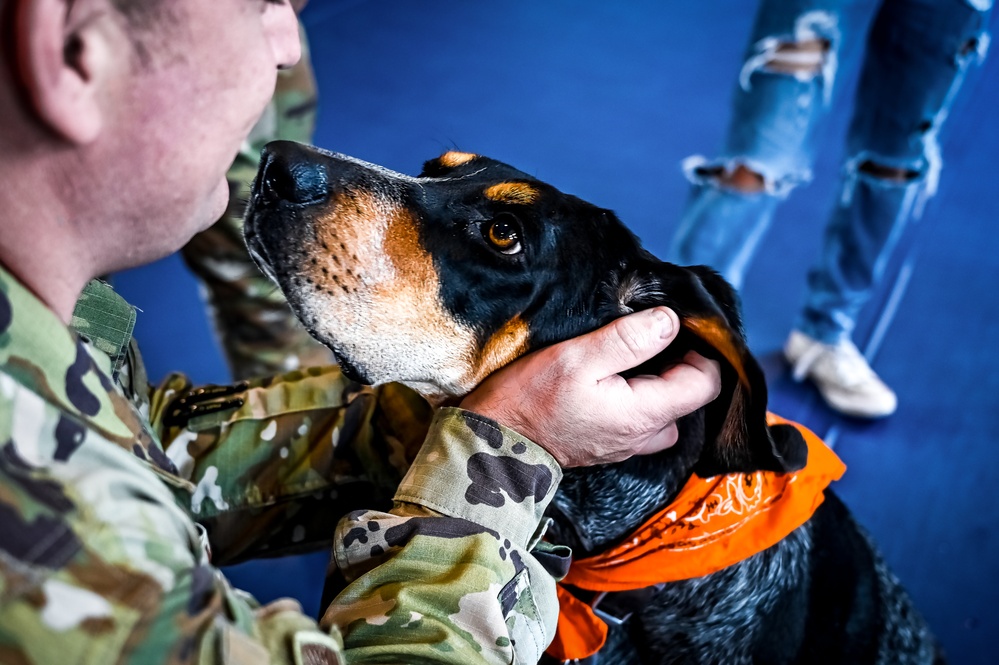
[{"left": 580, "top": 307, "right": 680, "bottom": 381}]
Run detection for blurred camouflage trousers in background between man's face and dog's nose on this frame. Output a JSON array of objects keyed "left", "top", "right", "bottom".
[{"left": 181, "top": 20, "right": 333, "bottom": 379}]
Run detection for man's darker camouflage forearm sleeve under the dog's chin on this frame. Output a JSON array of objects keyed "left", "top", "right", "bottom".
[{"left": 146, "top": 366, "right": 431, "bottom": 565}]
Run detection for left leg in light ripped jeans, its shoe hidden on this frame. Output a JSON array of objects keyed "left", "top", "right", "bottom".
[{"left": 668, "top": 0, "right": 871, "bottom": 288}]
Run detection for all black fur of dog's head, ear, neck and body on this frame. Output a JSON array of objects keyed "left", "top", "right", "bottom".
[{"left": 247, "top": 144, "right": 942, "bottom": 665}]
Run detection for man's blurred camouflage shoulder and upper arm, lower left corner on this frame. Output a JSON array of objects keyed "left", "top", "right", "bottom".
[{"left": 0, "top": 384, "right": 345, "bottom": 665}]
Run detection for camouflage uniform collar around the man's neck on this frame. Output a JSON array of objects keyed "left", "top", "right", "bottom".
[{"left": 0, "top": 265, "right": 168, "bottom": 462}]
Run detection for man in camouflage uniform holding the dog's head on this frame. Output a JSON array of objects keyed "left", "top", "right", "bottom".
[{"left": 0, "top": 0, "right": 719, "bottom": 665}]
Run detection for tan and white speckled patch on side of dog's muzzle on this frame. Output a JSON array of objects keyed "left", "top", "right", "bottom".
[{"left": 292, "top": 190, "right": 478, "bottom": 401}]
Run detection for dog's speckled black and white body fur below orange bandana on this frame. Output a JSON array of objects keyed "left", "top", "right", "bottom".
[{"left": 556, "top": 488, "right": 946, "bottom": 665}]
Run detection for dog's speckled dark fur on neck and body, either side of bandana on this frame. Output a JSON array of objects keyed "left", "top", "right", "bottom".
[{"left": 542, "top": 412, "right": 945, "bottom": 665}]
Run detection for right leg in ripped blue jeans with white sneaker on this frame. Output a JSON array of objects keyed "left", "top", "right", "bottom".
[{"left": 786, "top": 0, "right": 988, "bottom": 417}]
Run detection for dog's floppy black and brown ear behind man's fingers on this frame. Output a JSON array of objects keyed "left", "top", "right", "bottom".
[{"left": 608, "top": 261, "right": 808, "bottom": 478}]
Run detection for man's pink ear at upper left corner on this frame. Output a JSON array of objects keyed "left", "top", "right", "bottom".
[{"left": 9, "top": 0, "right": 115, "bottom": 144}]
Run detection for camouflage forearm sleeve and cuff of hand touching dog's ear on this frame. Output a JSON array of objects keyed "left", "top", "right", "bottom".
[{"left": 322, "top": 409, "right": 568, "bottom": 663}]
